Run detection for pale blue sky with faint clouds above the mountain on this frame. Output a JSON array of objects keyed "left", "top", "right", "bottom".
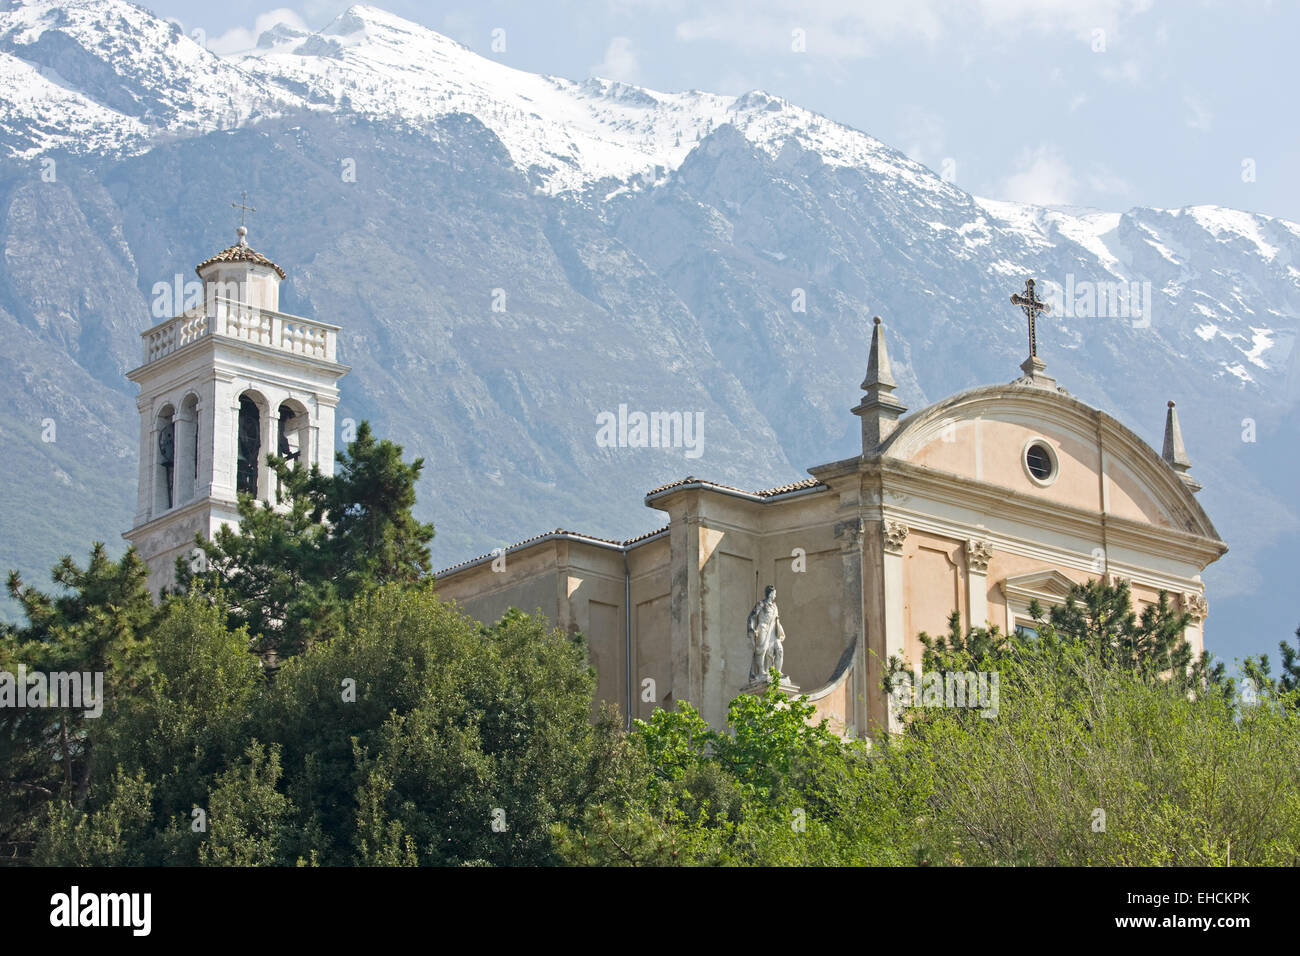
[{"left": 143, "top": 0, "right": 1300, "bottom": 221}]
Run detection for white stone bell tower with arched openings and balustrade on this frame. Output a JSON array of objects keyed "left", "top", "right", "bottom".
[{"left": 124, "top": 225, "right": 347, "bottom": 593}]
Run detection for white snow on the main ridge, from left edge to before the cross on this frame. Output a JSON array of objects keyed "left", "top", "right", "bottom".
[{"left": 0, "top": 0, "right": 1003, "bottom": 195}]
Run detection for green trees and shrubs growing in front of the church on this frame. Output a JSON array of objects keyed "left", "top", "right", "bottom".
[{"left": 0, "top": 424, "right": 1300, "bottom": 866}]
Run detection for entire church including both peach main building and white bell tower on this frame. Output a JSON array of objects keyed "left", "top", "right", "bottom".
[{"left": 126, "top": 234, "right": 1227, "bottom": 735}]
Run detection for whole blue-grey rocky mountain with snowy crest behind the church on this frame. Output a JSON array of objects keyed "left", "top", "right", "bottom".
[{"left": 0, "top": 0, "right": 1300, "bottom": 660}]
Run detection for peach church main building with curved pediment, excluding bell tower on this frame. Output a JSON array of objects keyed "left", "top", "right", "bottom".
[{"left": 438, "top": 312, "right": 1227, "bottom": 734}]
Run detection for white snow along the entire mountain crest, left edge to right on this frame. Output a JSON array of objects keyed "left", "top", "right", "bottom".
[{"left": 0, "top": 0, "right": 1300, "bottom": 386}]
